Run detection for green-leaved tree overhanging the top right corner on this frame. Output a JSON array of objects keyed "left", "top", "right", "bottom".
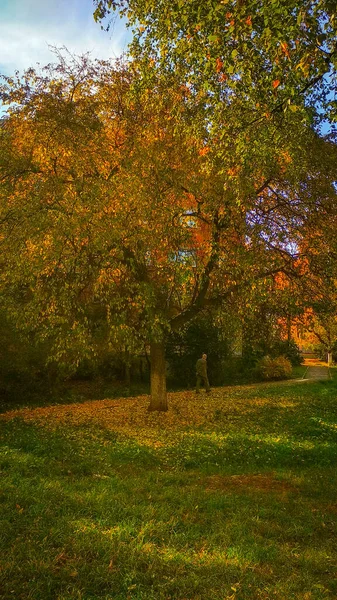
[{"left": 94, "top": 0, "right": 337, "bottom": 396}]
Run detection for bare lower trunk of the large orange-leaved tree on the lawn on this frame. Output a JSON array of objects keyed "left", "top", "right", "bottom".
[{"left": 148, "top": 340, "right": 168, "bottom": 411}]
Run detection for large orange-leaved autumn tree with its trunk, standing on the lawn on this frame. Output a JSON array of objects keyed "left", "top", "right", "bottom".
[{"left": 0, "top": 56, "right": 335, "bottom": 410}]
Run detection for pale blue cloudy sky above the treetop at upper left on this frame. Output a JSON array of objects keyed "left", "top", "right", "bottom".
[{"left": 0, "top": 0, "right": 130, "bottom": 75}]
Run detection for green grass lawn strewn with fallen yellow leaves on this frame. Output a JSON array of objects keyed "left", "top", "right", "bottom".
[{"left": 0, "top": 376, "right": 337, "bottom": 600}]
